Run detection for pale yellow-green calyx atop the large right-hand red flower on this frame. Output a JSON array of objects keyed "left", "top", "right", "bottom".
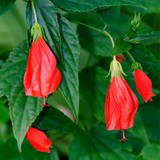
[{"left": 106, "top": 56, "right": 127, "bottom": 81}]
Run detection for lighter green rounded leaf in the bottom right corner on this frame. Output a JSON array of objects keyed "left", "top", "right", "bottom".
[{"left": 141, "top": 144, "right": 160, "bottom": 160}]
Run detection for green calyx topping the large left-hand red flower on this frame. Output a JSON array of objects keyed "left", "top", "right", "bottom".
[{"left": 31, "top": 23, "right": 47, "bottom": 42}]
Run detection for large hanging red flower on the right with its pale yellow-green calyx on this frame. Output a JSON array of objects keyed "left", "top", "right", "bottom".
[{"left": 105, "top": 57, "right": 138, "bottom": 141}]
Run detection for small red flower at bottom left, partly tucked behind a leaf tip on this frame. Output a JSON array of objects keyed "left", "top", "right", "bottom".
[{"left": 26, "top": 127, "right": 52, "bottom": 153}]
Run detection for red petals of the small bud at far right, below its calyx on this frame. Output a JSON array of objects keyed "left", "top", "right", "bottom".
[{"left": 134, "top": 70, "right": 155, "bottom": 102}]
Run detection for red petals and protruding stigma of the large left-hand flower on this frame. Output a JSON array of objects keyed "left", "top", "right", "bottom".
[{"left": 24, "top": 37, "right": 61, "bottom": 106}]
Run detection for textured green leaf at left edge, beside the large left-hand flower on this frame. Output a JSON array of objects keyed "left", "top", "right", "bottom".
[{"left": 0, "top": 41, "right": 29, "bottom": 98}]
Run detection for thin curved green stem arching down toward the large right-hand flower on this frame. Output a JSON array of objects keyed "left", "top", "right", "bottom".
[{"left": 71, "top": 20, "right": 114, "bottom": 48}]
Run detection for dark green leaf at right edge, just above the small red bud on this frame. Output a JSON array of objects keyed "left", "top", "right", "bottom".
[{"left": 130, "top": 44, "right": 160, "bottom": 83}]
